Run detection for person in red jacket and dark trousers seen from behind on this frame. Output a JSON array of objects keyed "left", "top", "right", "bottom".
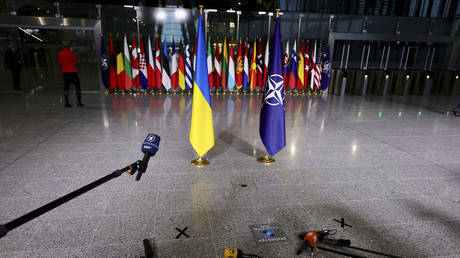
[{"left": 58, "top": 44, "right": 83, "bottom": 107}]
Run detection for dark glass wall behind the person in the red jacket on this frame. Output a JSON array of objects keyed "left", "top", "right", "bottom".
[{"left": 0, "top": 28, "right": 100, "bottom": 93}]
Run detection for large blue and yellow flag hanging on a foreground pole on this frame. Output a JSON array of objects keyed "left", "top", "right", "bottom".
[{"left": 189, "top": 14, "right": 214, "bottom": 157}]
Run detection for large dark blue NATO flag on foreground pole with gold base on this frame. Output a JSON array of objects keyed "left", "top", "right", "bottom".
[{"left": 259, "top": 18, "right": 286, "bottom": 156}]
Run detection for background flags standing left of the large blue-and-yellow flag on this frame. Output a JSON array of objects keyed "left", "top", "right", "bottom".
[{"left": 101, "top": 36, "right": 192, "bottom": 91}]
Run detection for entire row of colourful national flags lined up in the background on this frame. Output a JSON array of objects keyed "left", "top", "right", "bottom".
[{"left": 101, "top": 36, "right": 330, "bottom": 91}]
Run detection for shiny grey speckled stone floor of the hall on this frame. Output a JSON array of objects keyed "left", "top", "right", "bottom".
[{"left": 0, "top": 90, "right": 460, "bottom": 258}]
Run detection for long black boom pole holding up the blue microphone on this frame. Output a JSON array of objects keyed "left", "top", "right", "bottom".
[{"left": 0, "top": 159, "right": 150, "bottom": 238}]
